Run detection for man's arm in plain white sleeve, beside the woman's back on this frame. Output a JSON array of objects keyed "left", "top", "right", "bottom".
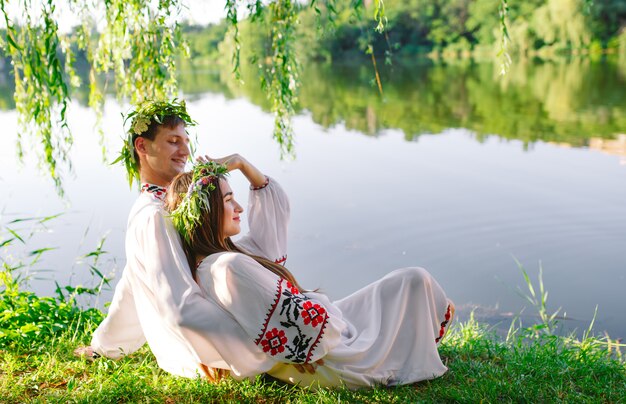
[{"left": 132, "top": 210, "right": 275, "bottom": 378}]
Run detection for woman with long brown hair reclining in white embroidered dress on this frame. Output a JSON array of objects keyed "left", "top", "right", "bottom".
[{"left": 167, "top": 161, "right": 454, "bottom": 388}]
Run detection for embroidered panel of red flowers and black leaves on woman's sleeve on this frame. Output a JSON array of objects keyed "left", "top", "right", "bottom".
[{"left": 254, "top": 278, "right": 328, "bottom": 363}]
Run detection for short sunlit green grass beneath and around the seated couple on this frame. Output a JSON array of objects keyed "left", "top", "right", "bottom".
[{"left": 0, "top": 307, "right": 626, "bottom": 403}]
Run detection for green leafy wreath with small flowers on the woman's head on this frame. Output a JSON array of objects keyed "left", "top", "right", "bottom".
[{"left": 170, "top": 161, "right": 228, "bottom": 242}]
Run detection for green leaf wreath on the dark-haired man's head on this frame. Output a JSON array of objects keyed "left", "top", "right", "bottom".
[{"left": 113, "top": 98, "right": 196, "bottom": 187}]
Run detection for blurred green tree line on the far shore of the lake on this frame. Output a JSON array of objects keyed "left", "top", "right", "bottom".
[{"left": 183, "top": 0, "right": 626, "bottom": 61}]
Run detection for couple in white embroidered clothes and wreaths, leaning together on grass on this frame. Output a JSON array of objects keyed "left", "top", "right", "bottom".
[{"left": 77, "top": 100, "right": 454, "bottom": 388}]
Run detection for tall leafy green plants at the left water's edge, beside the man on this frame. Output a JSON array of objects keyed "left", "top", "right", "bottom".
[{"left": 0, "top": 215, "right": 109, "bottom": 350}]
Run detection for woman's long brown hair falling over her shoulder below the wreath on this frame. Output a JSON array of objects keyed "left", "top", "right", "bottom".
[{"left": 166, "top": 172, "right": 303, "bottom": 290}]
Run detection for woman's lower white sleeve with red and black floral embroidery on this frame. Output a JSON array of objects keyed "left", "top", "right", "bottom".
[{"left": 204, "top": 253, "right": 336, "bottom": 363}]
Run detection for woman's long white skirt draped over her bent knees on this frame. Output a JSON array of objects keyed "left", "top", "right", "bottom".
[{"left": 268, "top": 268, "right": 451, "bottom": 388}]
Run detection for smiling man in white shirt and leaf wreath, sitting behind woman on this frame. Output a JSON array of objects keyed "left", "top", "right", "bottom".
[{"left": 76, "top": 101, "right": 300, "bottom": 378}]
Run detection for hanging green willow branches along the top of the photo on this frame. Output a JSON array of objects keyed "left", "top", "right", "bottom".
[{"left": 0, "top": 0, "right": 508, "bottom": 194}]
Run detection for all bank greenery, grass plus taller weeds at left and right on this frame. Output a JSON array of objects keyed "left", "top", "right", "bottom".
[{"left": 0, "top": 221, "right": 626, "bottom": 403}]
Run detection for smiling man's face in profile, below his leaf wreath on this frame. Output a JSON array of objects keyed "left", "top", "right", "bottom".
[{"left": 135, "top": 124, "right": 189, "bottom": 186}]
